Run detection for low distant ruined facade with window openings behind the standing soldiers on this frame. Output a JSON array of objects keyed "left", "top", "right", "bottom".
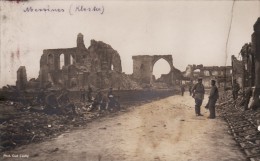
[{"left": 183, "top": 64, "right": 232, "bottom": 87}]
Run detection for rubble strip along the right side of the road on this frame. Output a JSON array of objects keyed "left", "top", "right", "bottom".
[{"left": 217, "top": 92, "right": 260, "bottom": 161}]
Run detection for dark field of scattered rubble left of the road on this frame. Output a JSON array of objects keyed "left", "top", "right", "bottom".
[{"left": 0, "top": 102, "right": 101, "bottom": 151}]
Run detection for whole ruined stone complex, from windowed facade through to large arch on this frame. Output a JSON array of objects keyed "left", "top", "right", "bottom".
[{"left": 12, "top": 33, "right": 185, "bottom": 90}]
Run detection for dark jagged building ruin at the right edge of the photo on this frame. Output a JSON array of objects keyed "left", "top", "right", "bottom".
[{"left": 232, "top": 18, "right": 260, "bottom": 108}]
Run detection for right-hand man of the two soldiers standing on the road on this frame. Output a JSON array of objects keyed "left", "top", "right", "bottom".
[{"left": 208, "top": 80, "right": 219, "bottom": 119}]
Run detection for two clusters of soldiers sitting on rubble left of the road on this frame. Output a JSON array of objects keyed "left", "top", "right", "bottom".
[{"left": 36, "top": 86, "right": 120, "bottom": 115}]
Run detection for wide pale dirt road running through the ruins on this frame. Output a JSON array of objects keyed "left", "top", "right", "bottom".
[{"left": 2, "top": 93, "right": 246, "bottom": 161}]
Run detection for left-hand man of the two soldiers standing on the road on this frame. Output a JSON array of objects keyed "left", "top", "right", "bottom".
[{"left": 192, "top": 78, "right": 205, "bottom": 116}]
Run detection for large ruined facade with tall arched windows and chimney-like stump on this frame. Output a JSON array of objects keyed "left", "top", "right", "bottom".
[{"left": 39, "top": 34, "right": 122, "bottom": 88}]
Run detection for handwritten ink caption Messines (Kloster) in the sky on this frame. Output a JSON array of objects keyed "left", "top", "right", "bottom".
[{"left": 23, "top": 4, "right": 105, "bottom": 15}]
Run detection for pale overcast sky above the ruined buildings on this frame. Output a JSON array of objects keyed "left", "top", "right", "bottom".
[{"left": 0, "top": 0, "right": 260, "bottom": 86}]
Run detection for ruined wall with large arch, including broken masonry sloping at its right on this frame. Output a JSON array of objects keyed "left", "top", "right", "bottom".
[{"left": 132, "top": 55, "right": 182, "bottom": 84}]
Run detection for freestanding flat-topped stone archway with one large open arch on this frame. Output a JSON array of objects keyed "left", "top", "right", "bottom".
[{"left": 132, "top": 55, "right": 174, "bottom": 84}]
